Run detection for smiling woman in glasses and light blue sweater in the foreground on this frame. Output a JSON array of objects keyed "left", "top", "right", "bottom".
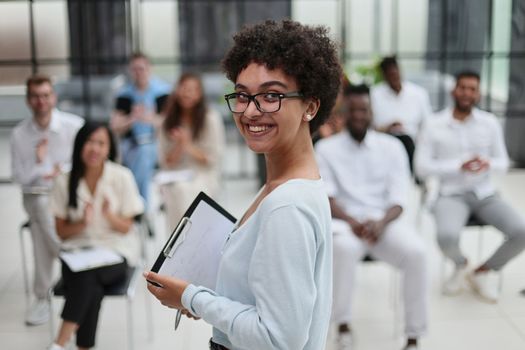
[{"left": 144, "top": 20, "right": 341, "bottom": 350}]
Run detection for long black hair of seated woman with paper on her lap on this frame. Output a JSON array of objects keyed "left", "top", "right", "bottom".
[{"left": 68, "top": 121, "right": 117, "bottom": 208}]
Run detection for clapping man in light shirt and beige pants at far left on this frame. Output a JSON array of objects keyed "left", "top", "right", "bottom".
[{"left": 11, "top": 74, "right": 84, "bottom": 325}]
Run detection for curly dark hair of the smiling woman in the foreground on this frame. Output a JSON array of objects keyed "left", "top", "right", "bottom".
[{"left": 222, "top": 20, "right": 342, "bottom": 133}]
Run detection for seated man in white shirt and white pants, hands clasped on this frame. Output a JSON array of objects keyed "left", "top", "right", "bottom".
[{"left": 316, "top": 85, "right": 427, "bottom": 350}]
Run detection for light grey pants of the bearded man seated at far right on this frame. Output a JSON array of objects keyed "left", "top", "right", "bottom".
[{"left": 433, "top": 192, "right": 525, "bottom": 271}]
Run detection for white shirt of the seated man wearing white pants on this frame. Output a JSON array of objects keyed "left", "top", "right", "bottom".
[{"left": 315, "top": 130, "right": 410, "bottom": 220}]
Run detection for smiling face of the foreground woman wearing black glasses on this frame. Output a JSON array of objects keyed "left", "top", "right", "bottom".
[{"left": 230, "top": 63, "right": 316, "bottom": 154}]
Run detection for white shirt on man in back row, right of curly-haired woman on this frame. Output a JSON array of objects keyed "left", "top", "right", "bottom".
[{"left": 370, "top": 81, "right": 432, "bottom": 140}]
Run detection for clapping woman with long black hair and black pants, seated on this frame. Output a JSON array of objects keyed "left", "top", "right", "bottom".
[{"left": 49, "top": 122, "right": 144, "bottom": 350}]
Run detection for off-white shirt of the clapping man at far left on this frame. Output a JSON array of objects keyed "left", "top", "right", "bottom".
[{"left": 11, "top": 109, "right": 84, "bottom": 193}]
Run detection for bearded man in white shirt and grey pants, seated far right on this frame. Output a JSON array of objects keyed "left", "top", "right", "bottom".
[{"left": 415, "top": 71, "right": 525, "bottom": 302}]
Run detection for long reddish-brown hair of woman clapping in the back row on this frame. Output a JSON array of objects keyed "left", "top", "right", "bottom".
[{"left": 162, "top": 72, "right": 206, "bottom": 140}]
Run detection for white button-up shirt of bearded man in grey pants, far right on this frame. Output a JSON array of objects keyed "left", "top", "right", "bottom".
[{"left": 415, "top": 108, "right": 509, "bottom": 198}]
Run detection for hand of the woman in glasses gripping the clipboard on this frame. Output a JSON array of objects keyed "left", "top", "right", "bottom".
[{"left": 144, "top": 271, "right": 189, "bottom": 309}]
